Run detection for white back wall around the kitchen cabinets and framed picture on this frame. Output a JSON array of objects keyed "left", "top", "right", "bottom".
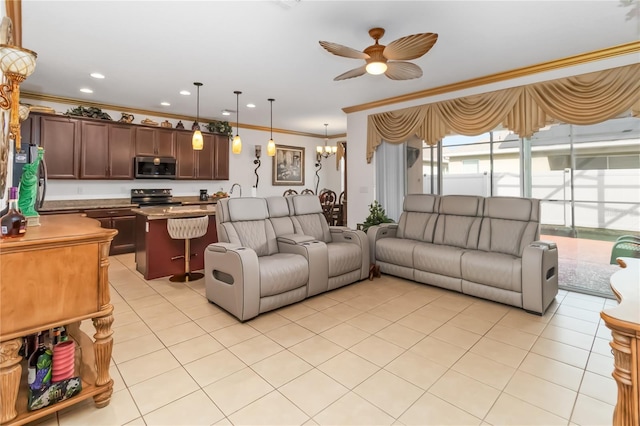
[{"left": 22, "top": 98, "right": 340, "bottom": 200}]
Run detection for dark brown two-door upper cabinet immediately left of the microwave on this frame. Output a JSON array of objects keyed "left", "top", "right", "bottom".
[{"left": 80, "top": 121, "right": 134, "bottom": 179}]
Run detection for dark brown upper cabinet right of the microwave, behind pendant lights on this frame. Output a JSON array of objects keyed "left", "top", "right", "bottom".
[{"left": 176, "top": 132, "right": 229, "bottom": 180}]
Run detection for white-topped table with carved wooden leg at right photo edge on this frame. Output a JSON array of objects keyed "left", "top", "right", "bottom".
[{"left": 600, "top": 257, "right": 640, "bottom": 426}]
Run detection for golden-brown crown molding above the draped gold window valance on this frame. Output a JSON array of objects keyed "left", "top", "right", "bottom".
[{"left": 342, "top": 41, "right": 640, "bottom": 114}]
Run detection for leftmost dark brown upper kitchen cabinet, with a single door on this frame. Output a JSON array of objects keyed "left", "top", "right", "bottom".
[{"left": 39, "top": 115, "right": 80, "bottom": 179}]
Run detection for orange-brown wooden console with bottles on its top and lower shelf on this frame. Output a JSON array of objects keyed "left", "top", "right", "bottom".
[{"left": 0, "top": 214, "right": 117, "bottom": 425}]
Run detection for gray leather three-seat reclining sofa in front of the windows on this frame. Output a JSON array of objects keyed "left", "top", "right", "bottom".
[{"left": 367, "top": 194, "right": 558, "bottom": 315}]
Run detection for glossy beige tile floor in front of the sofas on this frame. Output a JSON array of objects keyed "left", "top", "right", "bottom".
[{"left": 32, "top": 255, "right": 617, "bottom": 426}]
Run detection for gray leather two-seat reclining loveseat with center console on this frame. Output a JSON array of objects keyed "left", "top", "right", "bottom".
[{"left": 204, "top": 195, "right": 369, "bottom": 321}]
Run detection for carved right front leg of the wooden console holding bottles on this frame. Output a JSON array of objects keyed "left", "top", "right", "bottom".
[{"left": 93, "top": 314, "right": 113, "bottom": 408}]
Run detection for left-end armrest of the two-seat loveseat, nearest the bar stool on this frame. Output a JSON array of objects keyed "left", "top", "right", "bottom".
[{"left": 204, "top": 243, "right": 260, "bottom": 321}]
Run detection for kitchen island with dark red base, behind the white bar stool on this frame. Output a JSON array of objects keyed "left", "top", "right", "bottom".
[{"left": 132, "top": 204, "right": 218, "bottom": 280}]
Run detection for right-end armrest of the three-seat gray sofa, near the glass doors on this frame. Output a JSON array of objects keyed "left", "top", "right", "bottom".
[{"left": 522, "top": 241, "right": 558, "bottom": 315}]
